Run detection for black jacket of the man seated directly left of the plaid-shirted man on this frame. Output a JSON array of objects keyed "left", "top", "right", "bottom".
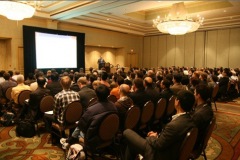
[{"left": 28, "top": 87, "right": 51, "bottom": 118}]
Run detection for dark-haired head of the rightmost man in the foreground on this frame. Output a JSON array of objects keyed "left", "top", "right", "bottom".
[{"left": 194, "top": 84, "right": 211, "bottom": 105}]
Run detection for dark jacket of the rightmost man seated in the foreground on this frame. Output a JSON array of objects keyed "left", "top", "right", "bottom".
[{"left": 192, "top": 103, "right": 213, "bottom": 149}]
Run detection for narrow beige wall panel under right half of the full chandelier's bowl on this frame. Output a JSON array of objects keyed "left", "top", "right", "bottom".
[{"left": 184, "top": 33, "right": 195, "bottom": 67}]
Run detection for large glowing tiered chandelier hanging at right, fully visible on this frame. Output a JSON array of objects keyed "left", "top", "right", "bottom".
[{"left": 153, "top": 2, "right": 204, "bottom": 35}]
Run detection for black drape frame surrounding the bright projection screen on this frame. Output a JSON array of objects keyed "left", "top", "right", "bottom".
[{"left": 23, "top": 25, "right": 85, "bottom": 76}]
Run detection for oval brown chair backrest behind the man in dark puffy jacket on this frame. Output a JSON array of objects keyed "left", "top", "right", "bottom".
[{"left": 98, "top": 113, "right": 119, "bottom": 141}]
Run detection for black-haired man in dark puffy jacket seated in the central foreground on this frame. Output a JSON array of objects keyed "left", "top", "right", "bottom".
[{"left": 60, "top": 84, "right": 118, "bottom": 149}]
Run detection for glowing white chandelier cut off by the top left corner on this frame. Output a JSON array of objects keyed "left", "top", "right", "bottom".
[{"left": 0, "top": 1, "right": 35, "bottom": 20}]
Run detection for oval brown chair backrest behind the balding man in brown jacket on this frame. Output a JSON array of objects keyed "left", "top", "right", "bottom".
[{"left": 124, "top": 106, "right": 141, "bottom": 129}]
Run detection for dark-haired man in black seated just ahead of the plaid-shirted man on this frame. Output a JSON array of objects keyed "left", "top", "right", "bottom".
[{"left": 46, "top": 72, "right": 63, "bottom": 97}]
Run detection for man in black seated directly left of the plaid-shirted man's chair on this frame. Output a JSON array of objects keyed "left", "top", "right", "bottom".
[{"left": 19, "top": 76, "right": 51, "bottom": 119}]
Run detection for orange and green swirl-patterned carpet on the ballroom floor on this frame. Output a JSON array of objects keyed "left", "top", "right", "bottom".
[{"left": 0, "top": 103, "right": 240, "bottom": 160}]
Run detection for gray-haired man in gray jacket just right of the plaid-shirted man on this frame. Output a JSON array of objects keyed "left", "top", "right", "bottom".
[{"left": 77, "top": 77, "right": 96, "bottom": 113}]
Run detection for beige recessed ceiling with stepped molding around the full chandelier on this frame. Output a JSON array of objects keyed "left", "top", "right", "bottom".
[{"left": 31, "top": 1, "right": 240, "bottom": 36}]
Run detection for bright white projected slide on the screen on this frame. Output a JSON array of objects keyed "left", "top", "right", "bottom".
[{"left": 35, "top": 32, "right": 77, "bottom": 69}]
